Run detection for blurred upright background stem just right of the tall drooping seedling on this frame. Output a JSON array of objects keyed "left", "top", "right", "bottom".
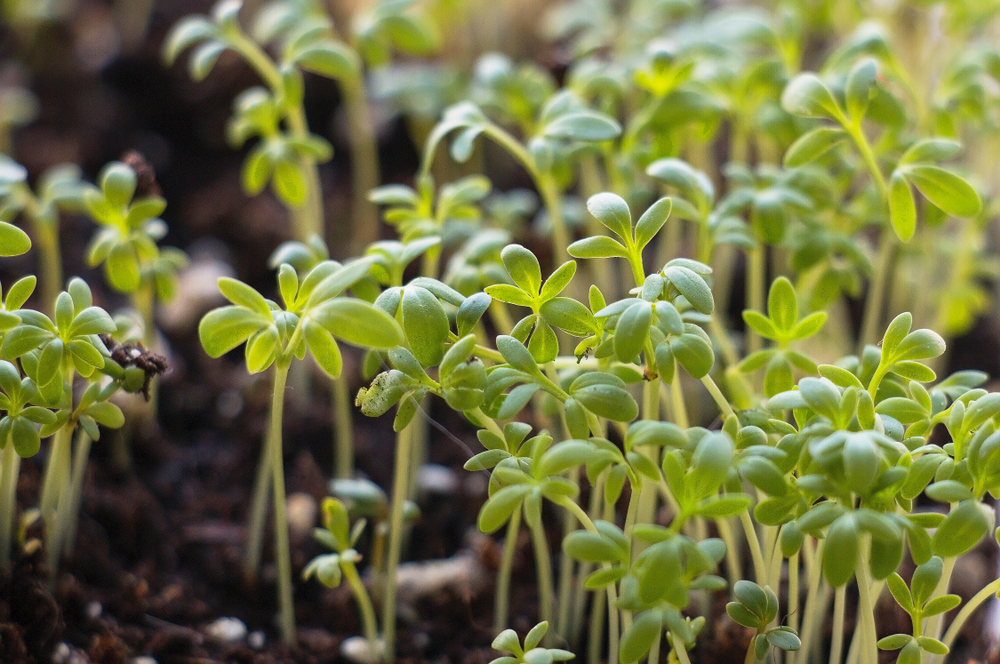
[{"left": 340, "top": 75, "right": 380, "bottom": 255}]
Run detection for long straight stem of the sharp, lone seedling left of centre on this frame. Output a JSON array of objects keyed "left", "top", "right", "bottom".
[{"left": 267, "top": 358, "right": 295, "bottom": 645}]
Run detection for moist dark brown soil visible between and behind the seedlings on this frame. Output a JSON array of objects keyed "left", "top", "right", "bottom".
[{"left": 0, "top": 0, "right": 1000, "bottom": 664}]
